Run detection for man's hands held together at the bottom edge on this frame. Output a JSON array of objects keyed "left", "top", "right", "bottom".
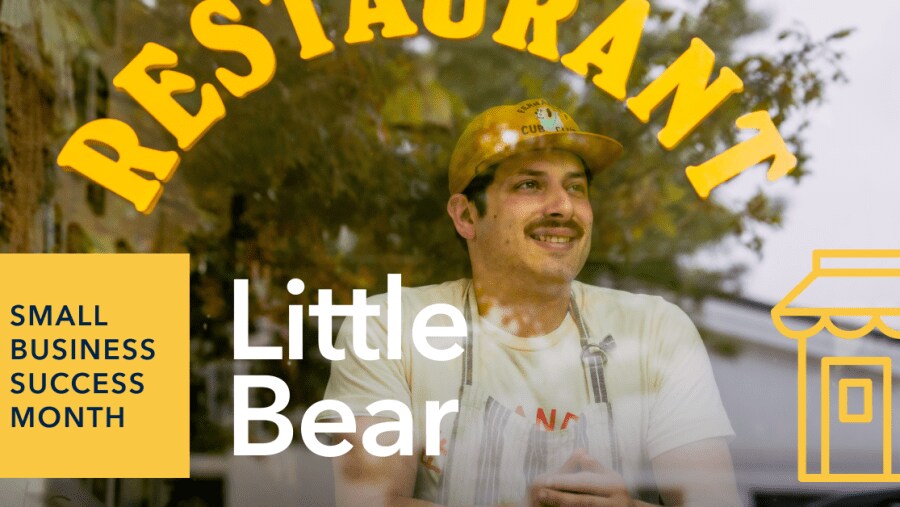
[{"left": 529, "top": 449, "right": 633, "bottom": 507}]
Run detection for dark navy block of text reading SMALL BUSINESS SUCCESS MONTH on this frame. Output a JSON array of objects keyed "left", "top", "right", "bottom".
[{"left": 8, "top": 304, "right": 156, "bottom": 428}]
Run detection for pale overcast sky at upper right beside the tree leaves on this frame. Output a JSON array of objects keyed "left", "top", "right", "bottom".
[{"left": 722, "top": 0, "right": 900, "bottom": 307}]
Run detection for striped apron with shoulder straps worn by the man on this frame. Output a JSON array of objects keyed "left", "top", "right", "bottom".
[{"left": 422, "top": 290, "right": 622, "bottom": 506}]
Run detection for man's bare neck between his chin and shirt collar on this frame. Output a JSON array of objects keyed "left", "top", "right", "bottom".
[{"left": 473, "top": 275, "right": 571, "bottom": 338}]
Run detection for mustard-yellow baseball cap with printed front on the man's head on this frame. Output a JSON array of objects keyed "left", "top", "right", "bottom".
[{"left": 450, "top": 99, "right": 622, "bottom": 194}]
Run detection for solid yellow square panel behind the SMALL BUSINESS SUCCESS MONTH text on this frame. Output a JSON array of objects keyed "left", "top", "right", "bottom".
[{"left": 0, "top": 254, "right": 190, "bottom": 477}]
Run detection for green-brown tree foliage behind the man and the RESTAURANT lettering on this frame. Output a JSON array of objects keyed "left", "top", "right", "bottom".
[{"left": 19, "top": 0, "right": 851, "bottom": 448}]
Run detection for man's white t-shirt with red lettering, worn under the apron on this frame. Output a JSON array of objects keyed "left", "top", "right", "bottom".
[{"left": 320, "top": 280, "right": 734, "bottom": 486}]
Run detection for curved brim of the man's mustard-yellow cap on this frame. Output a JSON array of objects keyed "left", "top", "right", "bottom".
[{"left": 475, "top": 132, "right": 623, "bottom": 182}]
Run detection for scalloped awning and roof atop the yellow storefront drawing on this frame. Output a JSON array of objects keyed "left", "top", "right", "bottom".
[{"left": 772, "top": 250, "right": 900, "bottom": 339}]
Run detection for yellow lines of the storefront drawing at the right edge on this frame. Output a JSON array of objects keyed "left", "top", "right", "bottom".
[{"left": 772, "top": 250, "right": 900, "bottom": 482}]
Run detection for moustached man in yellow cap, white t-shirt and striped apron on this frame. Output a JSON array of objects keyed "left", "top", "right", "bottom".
[{"left": 326, "top": 100, "right": 740, "bottom": 507}]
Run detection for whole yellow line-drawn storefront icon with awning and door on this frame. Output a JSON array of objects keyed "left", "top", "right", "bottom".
[{"left": 772, "top": 250, "right": 900, "bottom": 482}]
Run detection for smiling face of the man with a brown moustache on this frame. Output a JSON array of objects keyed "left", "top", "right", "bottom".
[{"left": 469, "top": 150, "right": 594, "bottom": 283}]
